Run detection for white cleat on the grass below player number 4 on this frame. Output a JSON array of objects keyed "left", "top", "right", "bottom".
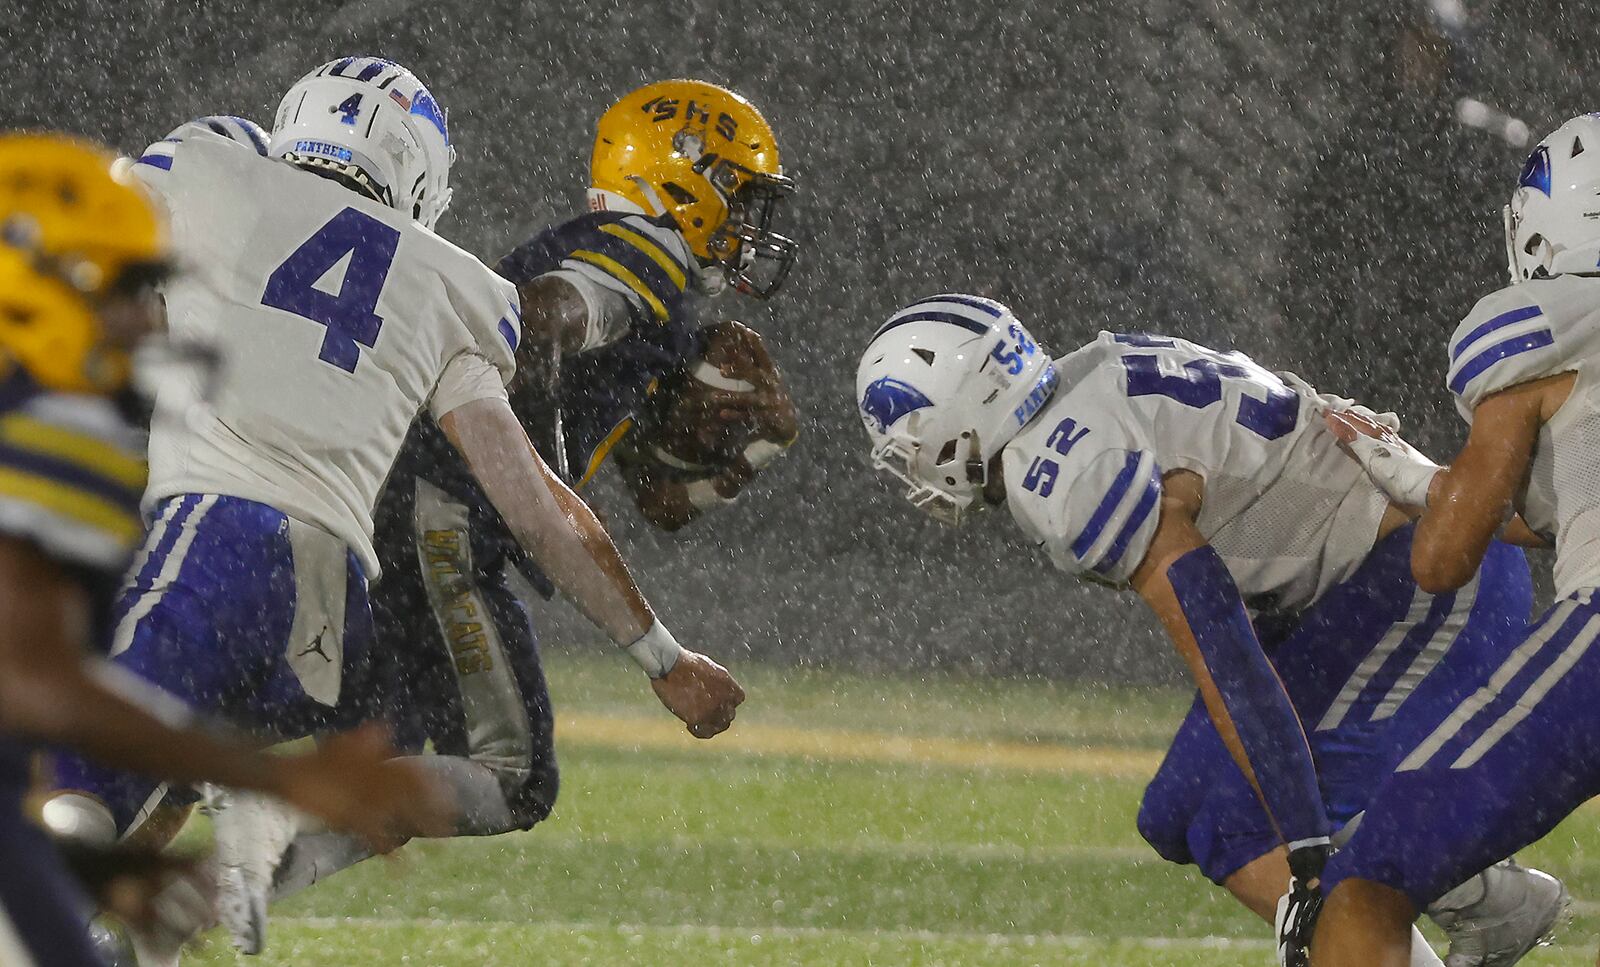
[{"left": 211, "top": 789, "right": 301, "bottom": 954}]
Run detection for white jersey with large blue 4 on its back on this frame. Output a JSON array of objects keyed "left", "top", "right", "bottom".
[{"left": 133, "top": 131, "right": 522, "bottom": 576}]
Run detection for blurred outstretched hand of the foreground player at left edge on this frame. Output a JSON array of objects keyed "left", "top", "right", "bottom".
[{"left": 278, "top": 725, "right": 456, "bottom": 852}]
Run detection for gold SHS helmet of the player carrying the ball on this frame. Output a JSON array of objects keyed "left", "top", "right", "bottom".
[{"left": 589, "top": 80, "right": 798, "bottom": 299}]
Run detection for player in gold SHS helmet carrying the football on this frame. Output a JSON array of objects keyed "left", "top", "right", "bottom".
[{"left": 243, "top": 80, "right": 798, "bottom": 934}]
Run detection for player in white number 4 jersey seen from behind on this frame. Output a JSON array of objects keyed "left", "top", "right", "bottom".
[{"left": 46, "top": 58, "right": 744, "bottom": 946}]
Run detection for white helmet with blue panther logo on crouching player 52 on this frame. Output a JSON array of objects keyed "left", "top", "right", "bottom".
[{"left": 856, "top": 295, "right": 1056, "bottom": 525}]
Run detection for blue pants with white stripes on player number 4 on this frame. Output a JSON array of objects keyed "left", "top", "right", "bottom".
[{"left": 56, "top": 493, "right": 373, "bottom": 833}]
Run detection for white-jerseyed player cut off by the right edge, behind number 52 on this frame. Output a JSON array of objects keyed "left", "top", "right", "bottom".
[{"left": 1312, "top": 114, "right": 1600, "bottom": 967}]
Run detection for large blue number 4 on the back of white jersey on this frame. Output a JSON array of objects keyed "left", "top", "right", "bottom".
[{"left": 261, "top": 208, "right": 400, "bottom": 373}]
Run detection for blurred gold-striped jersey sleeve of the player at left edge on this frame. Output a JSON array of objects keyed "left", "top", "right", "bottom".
[{"left": 0, "top": 371, "right": 146, "bottom": 573}]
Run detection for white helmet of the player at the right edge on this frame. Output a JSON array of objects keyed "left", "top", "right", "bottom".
[{"left": 1504, "top": 114, "right": 1600, "bottom": 283}]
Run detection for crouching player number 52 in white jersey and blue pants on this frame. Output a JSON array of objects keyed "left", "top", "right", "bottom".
[{"left": 856, "top": 295, "right": 1560, "bottom": 965}]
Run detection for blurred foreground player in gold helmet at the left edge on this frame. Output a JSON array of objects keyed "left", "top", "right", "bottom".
[{"left": 0, "top": 134, "right": 442, "bottom": 965}]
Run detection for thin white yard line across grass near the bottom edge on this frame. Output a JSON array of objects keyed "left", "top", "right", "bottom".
[{"left": 272, "top": 917, "right": 1274, "bottom": 949}]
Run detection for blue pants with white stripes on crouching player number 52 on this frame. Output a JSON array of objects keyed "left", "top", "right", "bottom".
[{"left": 1138, "top": 527, "right": 1533, "bottom": 884}]
